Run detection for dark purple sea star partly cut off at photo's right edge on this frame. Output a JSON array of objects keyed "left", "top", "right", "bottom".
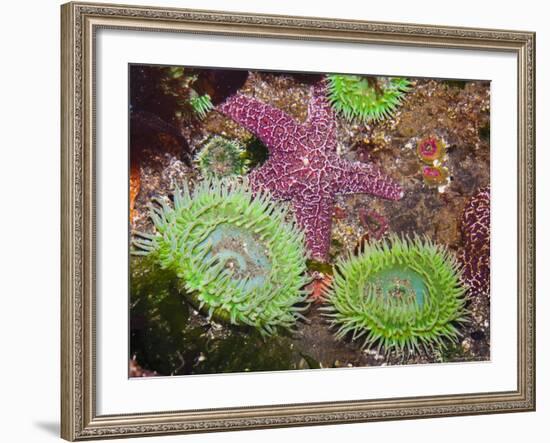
[{"left": 459, "top": 187, "right": 491, "bottom": 295}]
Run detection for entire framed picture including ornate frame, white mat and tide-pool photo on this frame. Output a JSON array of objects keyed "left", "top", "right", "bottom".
[{"left": 61, "top": 3, "right": 535, "bottom": 441}]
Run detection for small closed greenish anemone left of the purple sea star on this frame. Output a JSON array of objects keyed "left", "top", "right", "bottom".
[{"left": 195, "top": 135, "right": 248, "bottom": 178}]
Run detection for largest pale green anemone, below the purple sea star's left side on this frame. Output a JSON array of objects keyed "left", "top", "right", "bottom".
[{"left": 133, "top": 180, "right": 308, "bottom": 335}]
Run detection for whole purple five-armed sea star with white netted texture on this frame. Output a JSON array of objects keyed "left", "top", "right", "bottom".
[{"left": 217, "top": 82, "right": 403, "bottom": 261}]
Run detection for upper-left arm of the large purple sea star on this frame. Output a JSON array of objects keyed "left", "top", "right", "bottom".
[{"left": 217, "top": 94, "right": 298, "bottom": 153}]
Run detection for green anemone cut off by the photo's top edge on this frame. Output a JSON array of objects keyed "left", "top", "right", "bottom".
[{"left": 327, "top": 74, "right": 411, "bottom": 123}]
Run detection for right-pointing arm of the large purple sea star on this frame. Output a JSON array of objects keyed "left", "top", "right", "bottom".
[{"left": 334, "top": 160, "right": 404, "bottom": 200}]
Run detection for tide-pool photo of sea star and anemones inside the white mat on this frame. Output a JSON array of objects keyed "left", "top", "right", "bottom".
[{"left": 128, "top": 64, "right": 491, "bottom": 377}]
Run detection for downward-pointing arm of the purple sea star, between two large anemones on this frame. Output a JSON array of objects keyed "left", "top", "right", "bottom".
[{"left": 292, "top": 195, "right": 334, "bottom": 262}]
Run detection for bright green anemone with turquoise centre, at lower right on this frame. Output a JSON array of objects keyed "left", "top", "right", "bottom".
[{"left": 323, "top": 235, "right": 467, "bottom": 353}]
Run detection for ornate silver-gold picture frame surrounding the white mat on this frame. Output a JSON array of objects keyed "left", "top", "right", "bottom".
[{"left": 61, "top": 3, "right": 535, "bottom": 441}]
